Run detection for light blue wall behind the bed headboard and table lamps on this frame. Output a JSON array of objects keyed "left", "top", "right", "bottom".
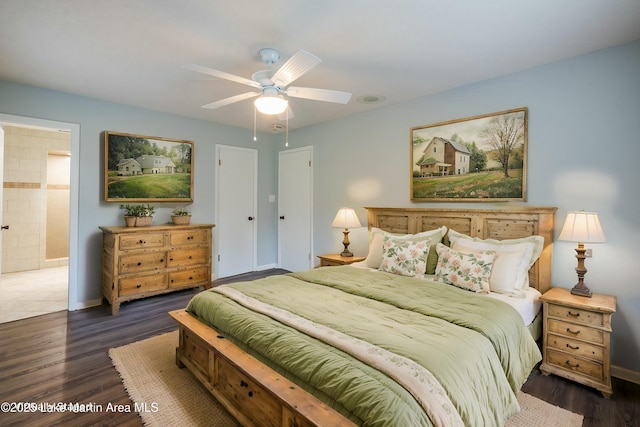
[{"left": 289, "top": 42, "right": 640, "bottom": 372}]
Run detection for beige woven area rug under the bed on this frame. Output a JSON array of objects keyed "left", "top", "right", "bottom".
[{"left": 109, "top": 331, "right": 583, "bottom": 427}]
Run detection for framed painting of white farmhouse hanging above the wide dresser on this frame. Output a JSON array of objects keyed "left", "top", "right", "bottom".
[{"left": 104, "top": 131, "right": 193, "bottom": 203}]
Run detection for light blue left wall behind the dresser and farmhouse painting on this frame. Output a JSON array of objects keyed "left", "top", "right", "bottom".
[{"left": 0, "top": 81, "right": 279, "bottom": 306}]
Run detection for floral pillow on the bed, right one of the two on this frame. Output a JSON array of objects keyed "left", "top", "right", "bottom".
[{"left": 436, "top": 243, "right": 496, "bottom": 294}]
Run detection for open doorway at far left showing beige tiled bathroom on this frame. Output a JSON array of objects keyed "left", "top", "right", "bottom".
[{"left": 0, "top": 117, "right": 77, "bottom": 322}]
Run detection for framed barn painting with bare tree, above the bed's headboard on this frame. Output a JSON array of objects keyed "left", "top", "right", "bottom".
[{"left": 410, "top": 108, "right": 527, "bottom": 202}]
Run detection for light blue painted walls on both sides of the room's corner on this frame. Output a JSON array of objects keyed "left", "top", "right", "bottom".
[{"left": 0, "top": 42, "right": 640, "bottom": 372}]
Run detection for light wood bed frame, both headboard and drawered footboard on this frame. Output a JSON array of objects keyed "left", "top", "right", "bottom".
[{"left": 170, "top": 207, "right": 556, "bottom": 426}]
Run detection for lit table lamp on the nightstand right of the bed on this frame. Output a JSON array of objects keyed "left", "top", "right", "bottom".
[{"left": 558, "top": 211, "right": 606, "bottom": 297}]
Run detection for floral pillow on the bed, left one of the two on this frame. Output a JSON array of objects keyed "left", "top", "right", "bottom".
[{"left": 379, "top": 236, "right": 429, "bottom": 279}]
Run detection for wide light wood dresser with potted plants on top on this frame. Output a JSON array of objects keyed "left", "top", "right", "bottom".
[{"left": 100, "top": 224, "right": 213, "bottom": 314}]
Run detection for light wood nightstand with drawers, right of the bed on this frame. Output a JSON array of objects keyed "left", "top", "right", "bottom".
[{"left": 540, "top": 288, "right": 616, "bottom": 398}]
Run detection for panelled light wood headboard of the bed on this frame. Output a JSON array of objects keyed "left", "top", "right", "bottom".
[{"left": 365, "top": 206, "right": 557, "bottom": 293}]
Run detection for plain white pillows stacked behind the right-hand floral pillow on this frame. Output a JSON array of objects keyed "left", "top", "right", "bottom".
[{"left": 449, "top": 230, "right": 544, "bottom": 294}]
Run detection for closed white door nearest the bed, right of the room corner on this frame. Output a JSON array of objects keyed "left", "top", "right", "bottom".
[{"left": 278, "top": 147, "right": 313, "bottom": 271}]
